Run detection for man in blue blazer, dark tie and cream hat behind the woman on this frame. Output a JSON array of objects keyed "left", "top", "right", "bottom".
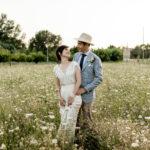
[{"left": 73, "top": 33, "right": 102, "bottom": 127}]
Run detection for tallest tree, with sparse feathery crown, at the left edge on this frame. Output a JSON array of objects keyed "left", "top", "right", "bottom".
[{"left": 0, "top": 14, "right": 26, "bottom": 52}]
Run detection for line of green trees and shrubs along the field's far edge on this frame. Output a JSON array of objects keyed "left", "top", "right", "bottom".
[{"left": 0, "top": 13, "right": 150, "bottom": 63}]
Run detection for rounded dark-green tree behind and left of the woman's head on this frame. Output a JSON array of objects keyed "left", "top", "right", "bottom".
[{"left": 29, "top": 30, "right": 62, "bottom": 54}]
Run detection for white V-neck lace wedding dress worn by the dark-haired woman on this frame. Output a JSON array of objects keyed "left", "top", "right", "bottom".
[{"left": 54, "top": 61, "right": 82, "bottom": 141}]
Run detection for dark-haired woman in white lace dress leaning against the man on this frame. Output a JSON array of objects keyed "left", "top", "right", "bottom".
[{"left": 54, "top": 45, "right": 82, "bottom": 142}]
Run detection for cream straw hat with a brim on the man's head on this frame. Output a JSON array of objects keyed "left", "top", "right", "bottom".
[{"left": 75, "top": 33, "right": 94, "bottom": 45}]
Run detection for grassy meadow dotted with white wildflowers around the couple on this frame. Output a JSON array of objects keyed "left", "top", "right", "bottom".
[{"left": 0, "top": 62, "right": 150, "bottom": 150}]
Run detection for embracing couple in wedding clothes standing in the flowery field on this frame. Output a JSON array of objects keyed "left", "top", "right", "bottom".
[{"left": 54, "top": 33, "right": 102, "bottom": 142}]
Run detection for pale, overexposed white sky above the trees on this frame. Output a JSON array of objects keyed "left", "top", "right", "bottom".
[{"left": 0, "top": 0, "right": 150, "bottom": 48}]
